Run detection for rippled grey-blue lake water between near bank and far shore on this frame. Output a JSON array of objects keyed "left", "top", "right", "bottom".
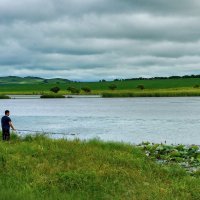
[{"left": 0, "top": 97, "right": 200, "bottom": 145}]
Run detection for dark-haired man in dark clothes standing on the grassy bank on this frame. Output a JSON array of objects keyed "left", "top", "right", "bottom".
[{"left": 1, "top": 110, "right": 15, "bottom": 141}]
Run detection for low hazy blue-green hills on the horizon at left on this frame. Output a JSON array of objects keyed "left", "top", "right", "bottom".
[{"left": 0, "top": 76, "right": 71, "bottom": 84}]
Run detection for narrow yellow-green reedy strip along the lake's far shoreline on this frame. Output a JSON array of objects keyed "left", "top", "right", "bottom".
[{"left": 0, "top": 88, "right": 200, "bottom": 98}]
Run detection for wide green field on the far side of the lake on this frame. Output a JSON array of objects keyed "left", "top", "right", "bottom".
[{"left": 0, "top": 78, "right": 200, "bottom": 96}]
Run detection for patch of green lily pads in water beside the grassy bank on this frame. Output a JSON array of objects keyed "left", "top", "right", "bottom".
[{"left": 139, "top": 142, "right": 200, "bottom": 174}]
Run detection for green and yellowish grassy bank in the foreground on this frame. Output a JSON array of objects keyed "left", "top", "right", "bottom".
[{"left": 0, "top": 135, "right": 200, "bottom": 200}]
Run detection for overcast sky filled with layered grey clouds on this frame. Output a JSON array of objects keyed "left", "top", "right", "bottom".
[{"left": 0, "top": 0, "right": 200, "bottom": 81}]
